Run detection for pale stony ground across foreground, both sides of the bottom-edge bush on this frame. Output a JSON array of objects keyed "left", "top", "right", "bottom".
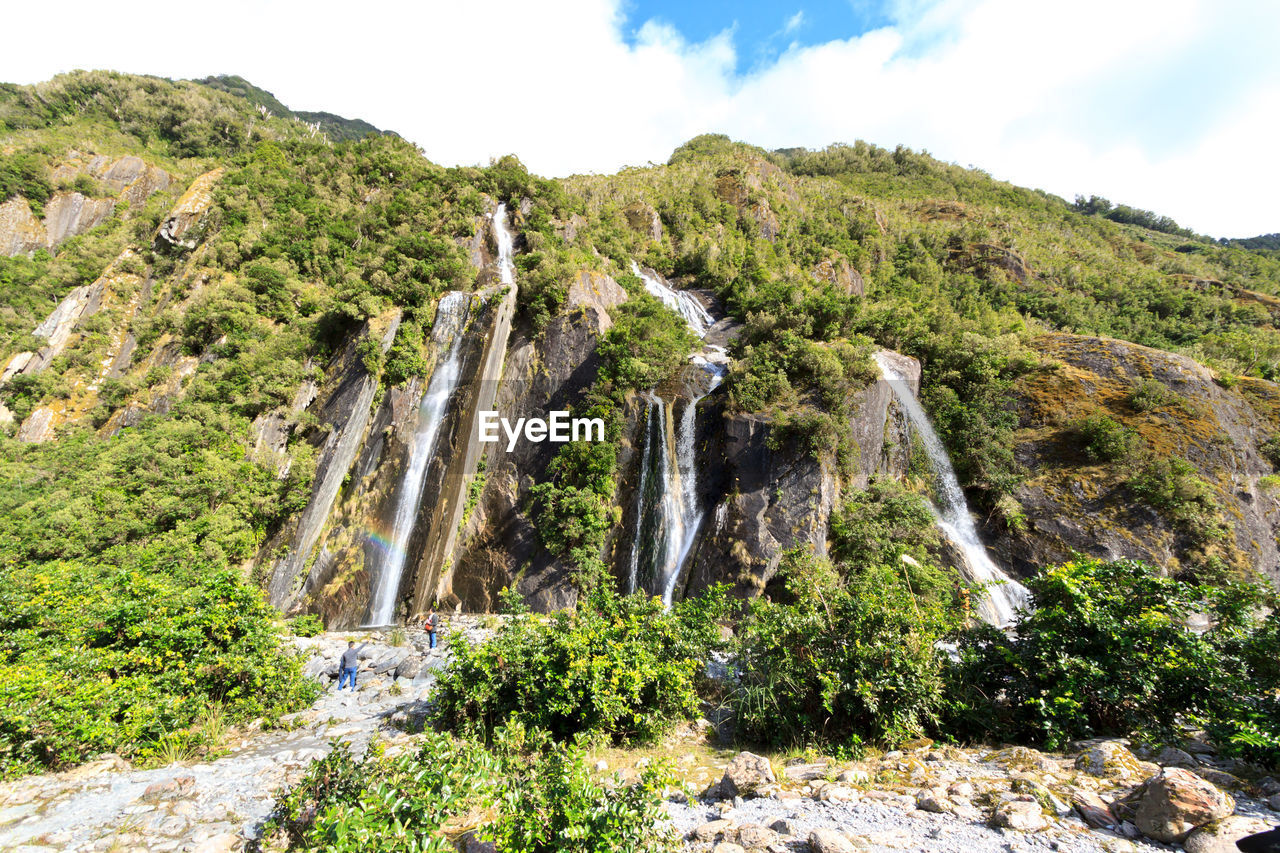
[{"left": 0, "top": 617, "right": 1280, "bottom": 853}]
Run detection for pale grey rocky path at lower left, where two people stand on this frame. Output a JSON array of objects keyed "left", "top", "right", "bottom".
[{"left": 0, "top": 619, "right": 484, "bottom": 853}]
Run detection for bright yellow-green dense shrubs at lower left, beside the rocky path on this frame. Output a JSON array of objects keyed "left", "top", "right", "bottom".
[{"left": 0, "top": 561, "right": 315, "bottom": 776}]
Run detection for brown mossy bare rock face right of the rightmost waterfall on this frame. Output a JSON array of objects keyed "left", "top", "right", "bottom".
[{"left": 989, "top": 334, "right": 1280, "bottom": 581}]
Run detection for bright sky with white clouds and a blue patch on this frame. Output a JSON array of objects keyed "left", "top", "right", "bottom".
[{"left": 0, "top": 0, "right": 1280, "bottom": 237}]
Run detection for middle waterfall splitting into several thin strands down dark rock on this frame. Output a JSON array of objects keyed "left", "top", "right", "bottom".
[{"left": 627, "top": 261, "right": 728, "bottom": 606}]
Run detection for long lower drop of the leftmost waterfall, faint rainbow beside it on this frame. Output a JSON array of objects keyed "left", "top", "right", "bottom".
[{"left": 366, "top": 291, "right": 471, "bottom": 626}]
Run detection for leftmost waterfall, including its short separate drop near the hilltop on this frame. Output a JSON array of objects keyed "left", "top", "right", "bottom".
[{"left": 365, "top": 204, "right": 515, "bottom": 626}]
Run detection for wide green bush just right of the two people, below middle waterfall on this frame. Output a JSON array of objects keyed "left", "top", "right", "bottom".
[{"left": 434, "top": 589, "right": 727, "bottom": 742}]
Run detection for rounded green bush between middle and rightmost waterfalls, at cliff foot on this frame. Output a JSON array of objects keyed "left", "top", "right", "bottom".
[{"left": 731, "top": 553, "right": 957, "bottom": 747}]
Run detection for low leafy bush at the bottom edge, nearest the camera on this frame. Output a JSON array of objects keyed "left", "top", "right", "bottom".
[{"left": 264, "top": 726, "right": 680, "bottom": 853}]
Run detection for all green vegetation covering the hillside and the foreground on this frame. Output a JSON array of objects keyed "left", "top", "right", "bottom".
[{"left": 0, "top": 73, "right": 1280, "bottom": 778}]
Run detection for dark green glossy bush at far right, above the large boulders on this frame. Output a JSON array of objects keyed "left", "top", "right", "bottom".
[{"left": 948, "top": 558, "right": 1280, "bottom": 754}]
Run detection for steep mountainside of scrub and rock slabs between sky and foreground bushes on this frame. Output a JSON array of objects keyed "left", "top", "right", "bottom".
[{"left": 0, "top": 73, "right": 1280, "bottom": 625}]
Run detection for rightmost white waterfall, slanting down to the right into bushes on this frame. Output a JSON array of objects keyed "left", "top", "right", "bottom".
[{"left": 873, "top": 352, "right": 1030, "bottom": 628}]
